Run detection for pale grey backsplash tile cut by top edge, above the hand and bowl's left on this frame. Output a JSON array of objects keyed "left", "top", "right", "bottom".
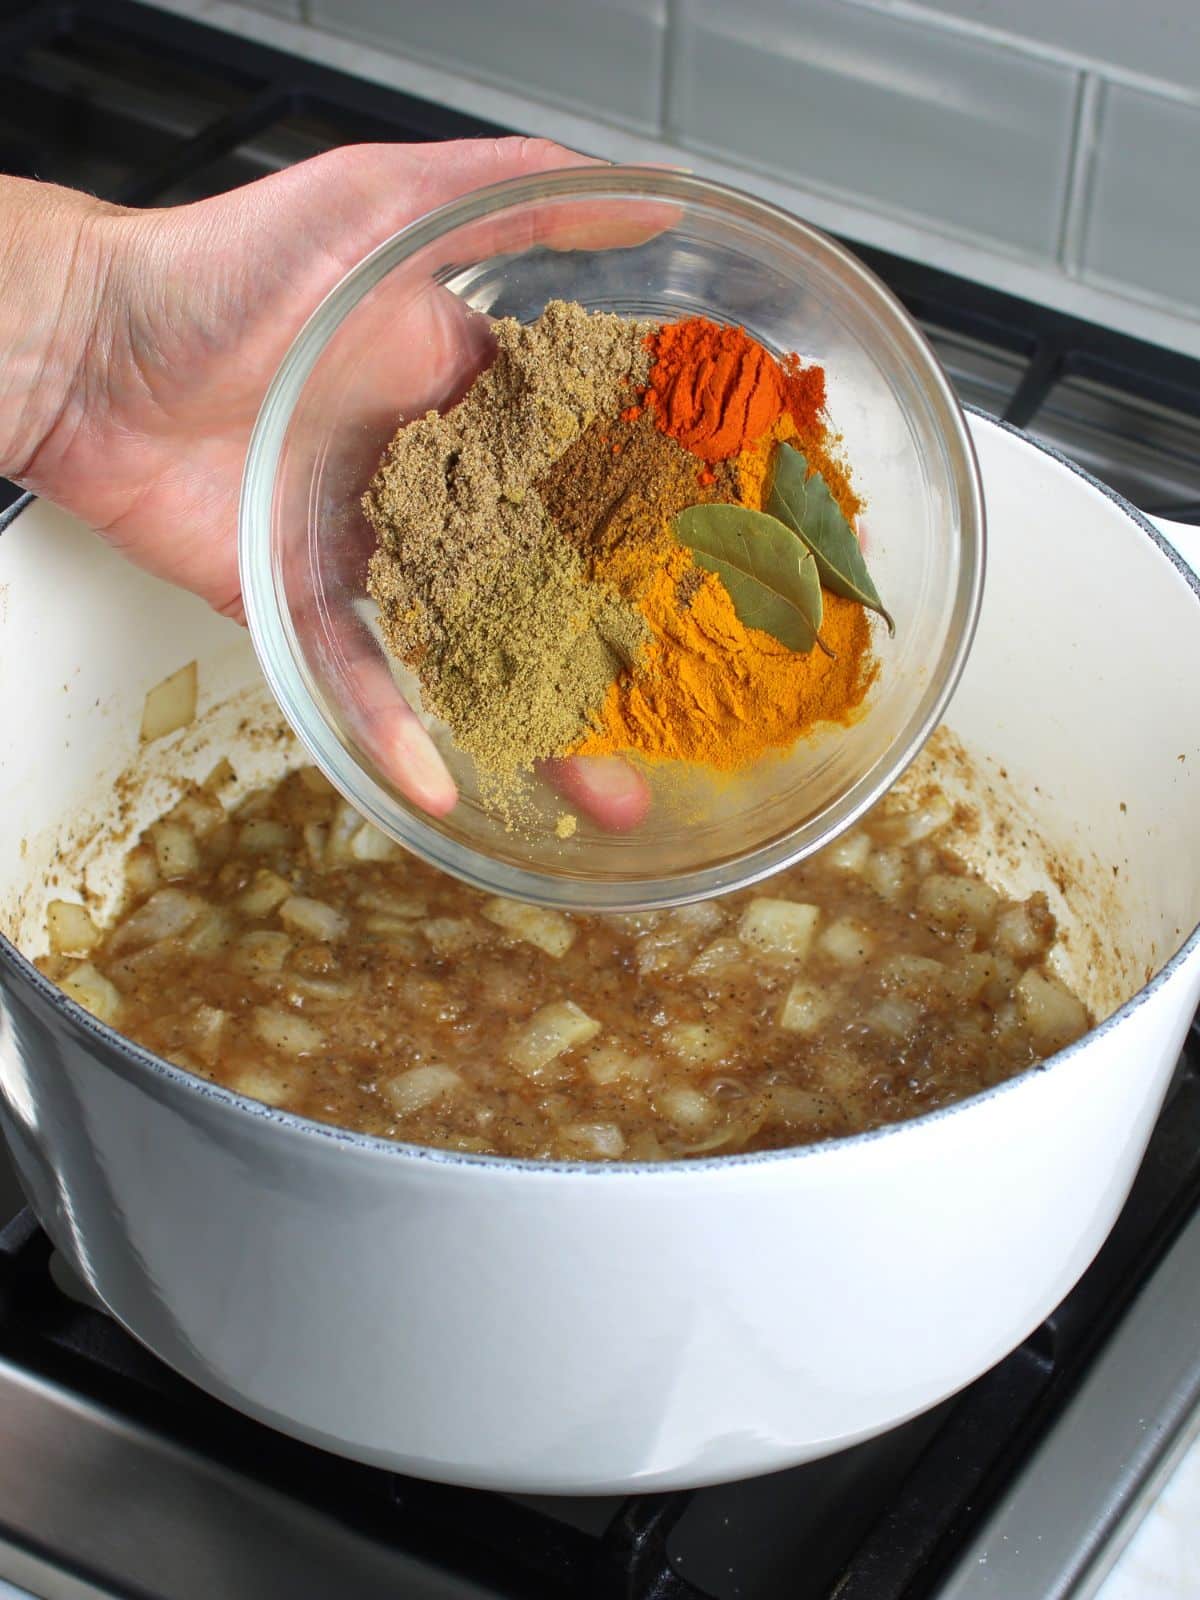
[{"left": 310, "top": 0, "right": 667, "bottom": 128}]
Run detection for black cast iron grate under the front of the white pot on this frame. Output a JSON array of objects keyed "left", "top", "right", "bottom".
[{"left": 0, "top": 1029, "right": 1200, "bottom": 1600}]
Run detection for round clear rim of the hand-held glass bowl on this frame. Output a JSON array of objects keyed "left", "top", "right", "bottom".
[{"left": 237, "top": 165, "right": 987, "bottom": 912}]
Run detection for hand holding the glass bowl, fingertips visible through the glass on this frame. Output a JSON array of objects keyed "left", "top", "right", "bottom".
[{"left": 0, "top": 139, "right": 646, "bottom": 829}]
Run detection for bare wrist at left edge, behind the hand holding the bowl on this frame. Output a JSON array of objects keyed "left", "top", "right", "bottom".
[{"left": 0, "top": 178, "right": 123, "bottom": 491}]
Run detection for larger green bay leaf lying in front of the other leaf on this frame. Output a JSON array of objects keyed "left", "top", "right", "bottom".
[{"left": 672, "top": 506, "right": 830, "bottom": 654}]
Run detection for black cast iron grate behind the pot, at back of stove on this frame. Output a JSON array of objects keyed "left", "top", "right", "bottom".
[{"left": 0, "top": 0, "right": 1200, "bottom": 522}]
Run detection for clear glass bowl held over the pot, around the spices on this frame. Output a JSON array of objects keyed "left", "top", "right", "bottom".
[{"left": 240, "top": 166, "right": 984, "bottom": 910}]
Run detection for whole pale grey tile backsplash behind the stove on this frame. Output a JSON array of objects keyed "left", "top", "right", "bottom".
[{"left": 242, "top": 0, "right": 1200, "bottom": 328}]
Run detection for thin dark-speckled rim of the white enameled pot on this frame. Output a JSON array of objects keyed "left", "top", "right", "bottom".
[{"left": 0, "top": 405, "right": 1200, "bottom": 1182}]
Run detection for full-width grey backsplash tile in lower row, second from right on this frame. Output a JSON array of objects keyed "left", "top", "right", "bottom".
[{"left": 678, "top": 0, "right": 1078, "bottom": 259}]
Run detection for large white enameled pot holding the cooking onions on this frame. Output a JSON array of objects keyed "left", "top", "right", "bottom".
[{"left": 0, "top": 419, "right": 1200, "bottom": 1493}]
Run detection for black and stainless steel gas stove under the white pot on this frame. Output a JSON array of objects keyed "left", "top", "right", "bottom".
[{"left": 0, "top": 0, "right": 1200, "bottom": 1600}]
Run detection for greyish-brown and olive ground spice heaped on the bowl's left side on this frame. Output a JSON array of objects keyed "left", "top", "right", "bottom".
[{"left": 363, "top": 301, "right": 650, "bottom": 781}]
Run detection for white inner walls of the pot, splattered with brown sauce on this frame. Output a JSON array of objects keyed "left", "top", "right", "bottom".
[{"left": 0, "top": 421, "right": 1200, "bottom": 1036}]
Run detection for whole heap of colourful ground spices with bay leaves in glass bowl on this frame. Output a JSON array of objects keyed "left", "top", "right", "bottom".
[{"left": 363, "top": 301, "right": 882, "bottom": 806}]
